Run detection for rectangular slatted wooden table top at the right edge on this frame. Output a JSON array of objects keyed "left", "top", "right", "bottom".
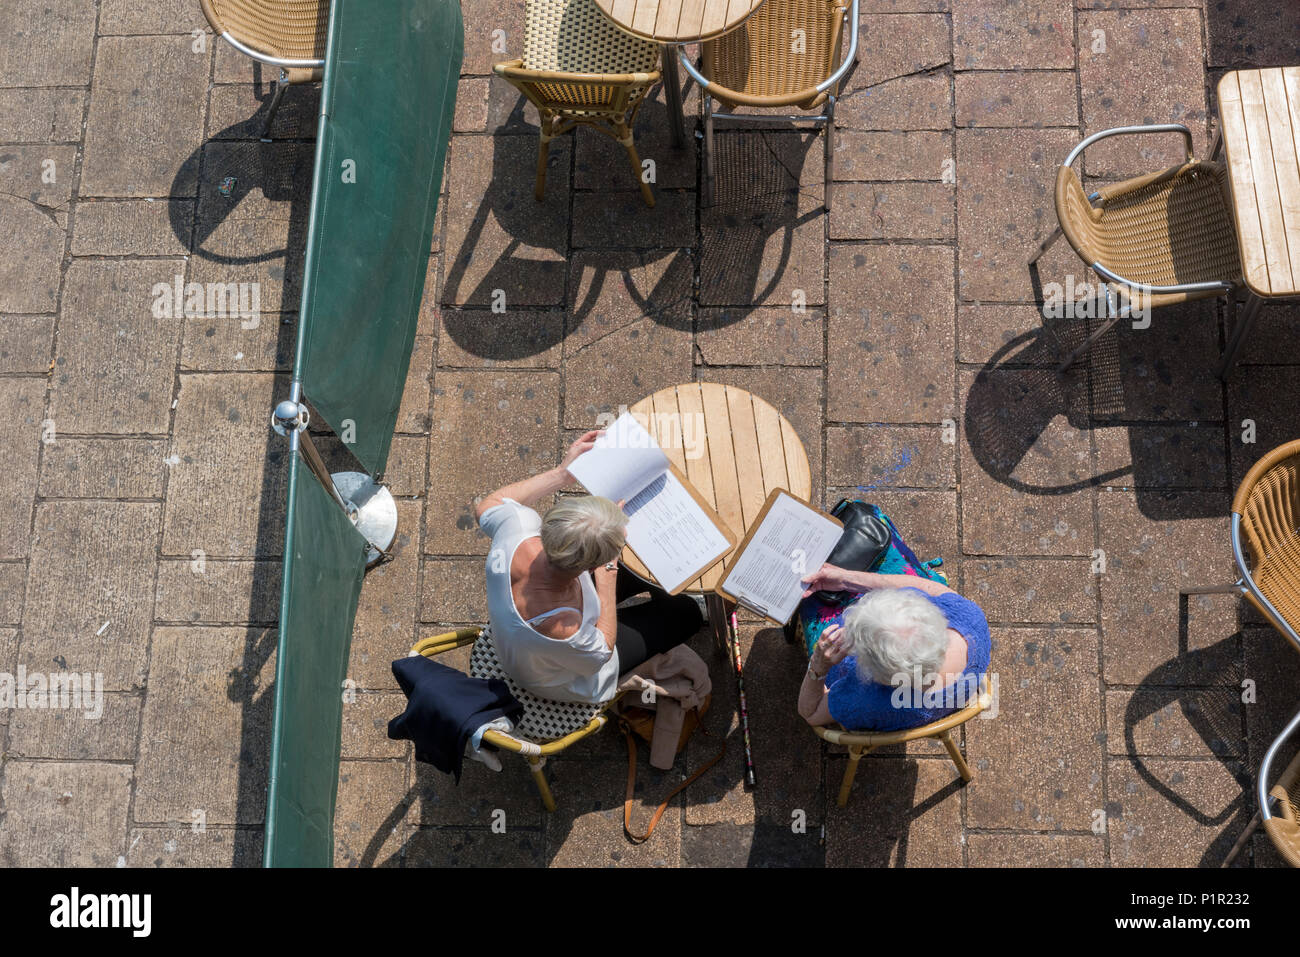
[{"left": 1218, "top": 66, "right": 1300, "bottom": 296}]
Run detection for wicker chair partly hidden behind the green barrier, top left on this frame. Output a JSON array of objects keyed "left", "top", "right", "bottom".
[{"left": 199, "top": 0, "right": 329, "bottom": 143}]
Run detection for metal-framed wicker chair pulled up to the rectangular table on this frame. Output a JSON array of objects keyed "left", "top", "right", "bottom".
[{"left": 1030, "top": 124, "right": 1253, "bottom": 376}]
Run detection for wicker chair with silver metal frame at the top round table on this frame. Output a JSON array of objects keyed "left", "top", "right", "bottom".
[{"left": 677, "top": 0, "right": 858, "bottom": 211}]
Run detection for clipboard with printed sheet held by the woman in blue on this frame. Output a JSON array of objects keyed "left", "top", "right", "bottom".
[{"left": 716, "top": 489, "right": 844, "bottom": 624}]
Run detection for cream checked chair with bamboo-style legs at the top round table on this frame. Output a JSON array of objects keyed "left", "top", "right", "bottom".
[{"left": 493, "top": 0, "right": 659, "bottom": 207}]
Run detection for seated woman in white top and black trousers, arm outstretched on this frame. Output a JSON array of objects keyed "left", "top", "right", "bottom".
[{"left": 476, "top": 432, "right": 703, "bottom": 703}]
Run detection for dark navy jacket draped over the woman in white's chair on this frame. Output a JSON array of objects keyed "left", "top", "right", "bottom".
[{"left": 389, "top": 654, "right": 524, "bottom": 784}]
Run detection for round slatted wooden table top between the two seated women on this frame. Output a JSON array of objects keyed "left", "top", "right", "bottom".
[{"left": 623, "top": 382, "right": 813, "bottom": 594}]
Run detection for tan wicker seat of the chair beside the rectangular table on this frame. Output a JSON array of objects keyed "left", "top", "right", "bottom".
[{"left": 1084, "top": 163, "right": 1242, "bottom": 306}]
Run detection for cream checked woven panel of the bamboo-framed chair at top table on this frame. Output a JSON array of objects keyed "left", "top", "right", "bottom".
[{"left": 523, "top": 0, "right": 659, "bottom": 74}]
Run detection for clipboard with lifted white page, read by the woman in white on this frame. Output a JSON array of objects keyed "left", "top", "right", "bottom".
[{"left": 569, "top": 412, "right": 736, "bottom": 594}]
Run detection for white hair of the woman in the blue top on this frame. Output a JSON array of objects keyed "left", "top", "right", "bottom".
[{"left": 844, "top": 588, "right": 948, "bottom": 688}]
